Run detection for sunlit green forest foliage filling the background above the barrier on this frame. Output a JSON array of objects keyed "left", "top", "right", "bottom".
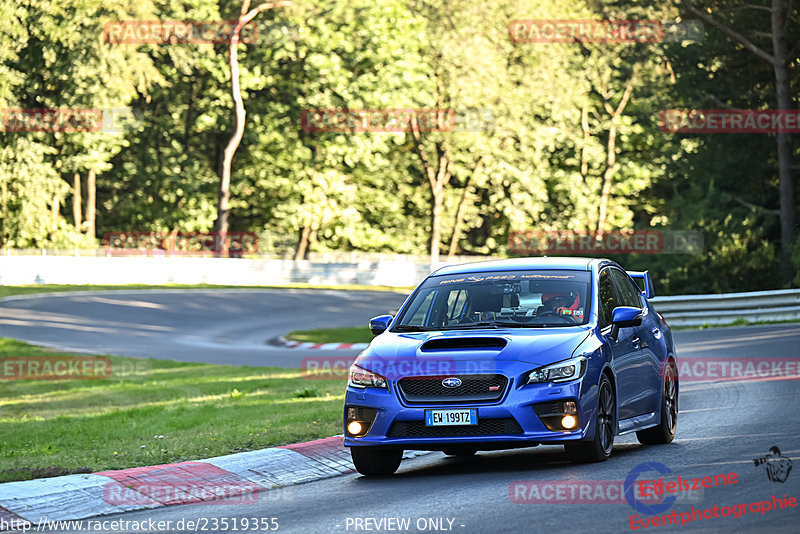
[{"left": 0, "top": 0, "right": 800, "bottom": 294}]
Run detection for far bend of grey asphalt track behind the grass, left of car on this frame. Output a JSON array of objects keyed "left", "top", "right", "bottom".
[{"left": 0, "top": 289, "right": 406, "bottom": 367}]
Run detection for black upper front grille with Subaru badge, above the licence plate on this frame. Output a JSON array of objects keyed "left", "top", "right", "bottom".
[{"left": 397, "top": 374, "right": 508, "bottom": 404}]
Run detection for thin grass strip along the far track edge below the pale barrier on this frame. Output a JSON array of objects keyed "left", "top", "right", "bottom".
[{"left": 0, "top": 284, "right": 413, "bottom": 298}]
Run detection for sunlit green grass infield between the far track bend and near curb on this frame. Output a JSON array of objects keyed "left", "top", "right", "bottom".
[{"left": 0, "top": 338, "right": 345, "bottom": 482}]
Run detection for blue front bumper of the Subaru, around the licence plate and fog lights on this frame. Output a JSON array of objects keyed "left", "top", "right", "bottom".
[{"left": 344, "top": 362, "right": 597, "bottom": 450}]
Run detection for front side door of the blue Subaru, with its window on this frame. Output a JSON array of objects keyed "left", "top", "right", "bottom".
[{"left": 597, "top": 268, "right": 641, "bottom": 426}]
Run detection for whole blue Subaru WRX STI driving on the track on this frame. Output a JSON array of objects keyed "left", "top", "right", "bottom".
[{"left": 344, "top": 258, "right": 678, "bottom": 475}]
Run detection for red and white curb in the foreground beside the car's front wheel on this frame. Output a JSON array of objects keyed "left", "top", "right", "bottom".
[{"left": 0, "top": 436, "right": 428, "bottom": 530}]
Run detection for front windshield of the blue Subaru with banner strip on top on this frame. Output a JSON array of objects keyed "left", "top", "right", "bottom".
[{"left": 392, "top": 270, "right": 590, "bottom": 332}]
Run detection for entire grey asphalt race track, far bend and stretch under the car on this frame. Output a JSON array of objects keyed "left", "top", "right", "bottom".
[{"left": 0, "top": 290, "right": 800, "bottom": 533}]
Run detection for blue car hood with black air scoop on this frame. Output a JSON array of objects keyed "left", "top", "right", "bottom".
[{"left": 356, "top": 325, "right": 592, "bottom": 375}]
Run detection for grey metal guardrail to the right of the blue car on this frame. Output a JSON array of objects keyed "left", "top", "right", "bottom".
[{"left": 650, "top": 289, "right": 800, "bottom": 326}]
